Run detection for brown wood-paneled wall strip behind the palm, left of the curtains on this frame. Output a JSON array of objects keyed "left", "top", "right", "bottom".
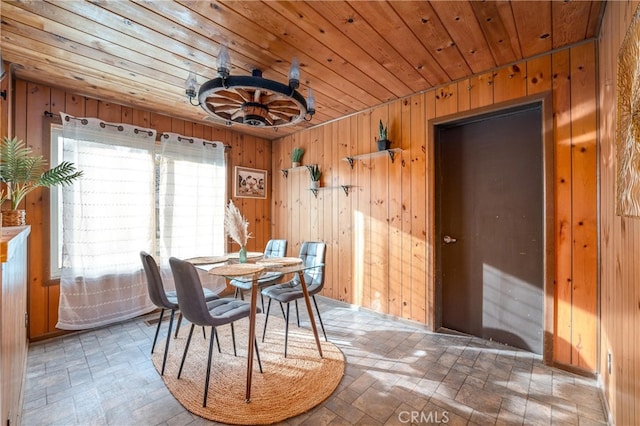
[{"left": 21, "top": 82, "right": 51, "bottom": 336}]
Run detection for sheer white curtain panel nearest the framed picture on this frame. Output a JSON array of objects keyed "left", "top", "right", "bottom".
[{"left": 157, "top": 133, "right": 227, "bottom": 291}]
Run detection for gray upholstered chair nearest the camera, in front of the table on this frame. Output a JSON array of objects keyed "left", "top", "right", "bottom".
[{"left": 169, "top": 257, "right": 262, "bottom": 407}]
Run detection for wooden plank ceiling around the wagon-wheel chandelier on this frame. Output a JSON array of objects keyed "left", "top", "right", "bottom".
[{"left": 1, "top": 0, "right": 604, "bottom": 139}]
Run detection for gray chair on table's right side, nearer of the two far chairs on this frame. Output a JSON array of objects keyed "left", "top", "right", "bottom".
[{"left": 262, "top": 241, "right": 327, "bottom": 358}]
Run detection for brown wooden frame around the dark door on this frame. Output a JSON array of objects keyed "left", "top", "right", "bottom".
[{"left": 427, "top": 92, "right": 555, "bottom": 364}]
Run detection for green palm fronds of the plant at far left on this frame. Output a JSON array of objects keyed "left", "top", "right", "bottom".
[{"left": 0, "top": 136, "right": 82, "bottom": 210}]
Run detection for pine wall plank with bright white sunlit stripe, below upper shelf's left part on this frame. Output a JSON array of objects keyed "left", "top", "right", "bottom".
[{"left": 353, "top": 111, "right": 374, "bottom": 308}]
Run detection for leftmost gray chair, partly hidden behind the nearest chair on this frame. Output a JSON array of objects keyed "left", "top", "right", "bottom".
[{"left": 140, "top": 251, "right": 220, "bottom": 375}]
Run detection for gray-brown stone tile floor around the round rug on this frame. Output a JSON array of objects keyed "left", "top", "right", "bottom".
[{"left": 22, "top": 297, "right": 606, "bottom": 426}]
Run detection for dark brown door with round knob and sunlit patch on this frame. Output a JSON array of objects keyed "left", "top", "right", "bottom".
[{"left": 435, "top": 104, "right": 544, "bottom": 354}]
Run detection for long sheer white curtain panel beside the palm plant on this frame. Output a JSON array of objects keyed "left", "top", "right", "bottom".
[{"left": 56, "top": 114, "right": 156, "bottom": 330}]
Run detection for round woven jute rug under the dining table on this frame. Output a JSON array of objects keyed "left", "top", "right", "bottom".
[{"left": 152, "top": 314, "right": 345, "bottom": 425}]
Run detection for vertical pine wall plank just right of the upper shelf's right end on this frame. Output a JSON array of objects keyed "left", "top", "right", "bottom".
[{"left": 396, "top": 99, "right": 417, "bottom": 319}]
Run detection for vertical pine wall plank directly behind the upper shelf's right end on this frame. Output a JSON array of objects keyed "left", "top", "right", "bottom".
[{"left": 385, "top": 102, "right": 404, "bottom": 317}]
